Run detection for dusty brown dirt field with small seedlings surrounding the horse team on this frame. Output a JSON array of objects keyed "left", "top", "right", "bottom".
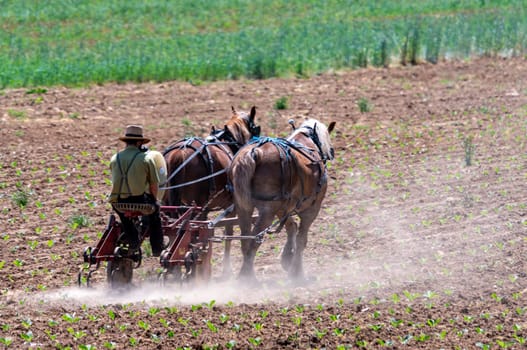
[{"left": 0, "top": 59, "right": 527, "bottom": 349}]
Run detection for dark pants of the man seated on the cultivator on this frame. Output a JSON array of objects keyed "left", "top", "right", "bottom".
[{"left": 116, "top": 194, "right": 163, "bottom": 256}]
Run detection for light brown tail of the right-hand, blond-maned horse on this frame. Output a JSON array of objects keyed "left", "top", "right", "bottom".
[{"left": 230, "top": 148, "right": 261, "bottom": 211}]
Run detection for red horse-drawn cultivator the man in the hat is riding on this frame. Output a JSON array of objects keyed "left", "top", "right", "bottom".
[{"left": 78, "top": 204, "right": 219, "bottom": 287}]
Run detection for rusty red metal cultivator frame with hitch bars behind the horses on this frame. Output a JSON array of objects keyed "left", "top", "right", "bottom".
[{"left": 77, "top": 205, "right": 249, "bottom": 287}]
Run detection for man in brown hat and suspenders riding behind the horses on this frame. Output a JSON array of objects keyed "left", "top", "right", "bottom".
[{"left": 109, "top": 125, "right": 163, "bottom": 257}]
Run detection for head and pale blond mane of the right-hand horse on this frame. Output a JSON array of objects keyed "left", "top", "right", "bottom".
[{"left": 288, "top": 118, "right": 336, "bottom": 162}]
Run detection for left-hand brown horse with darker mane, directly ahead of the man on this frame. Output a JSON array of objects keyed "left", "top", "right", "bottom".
[{"left": 162, "top": 107, "right": 260, "bottom": 274}]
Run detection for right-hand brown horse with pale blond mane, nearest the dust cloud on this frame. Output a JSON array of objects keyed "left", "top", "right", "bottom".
[{"left": 227, "top": 119, "right": 335, "bottom": 280}]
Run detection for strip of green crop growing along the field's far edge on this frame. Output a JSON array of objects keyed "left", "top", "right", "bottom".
[{"left": 0, "top": 0, "right": 527, "bottom": 87}]
